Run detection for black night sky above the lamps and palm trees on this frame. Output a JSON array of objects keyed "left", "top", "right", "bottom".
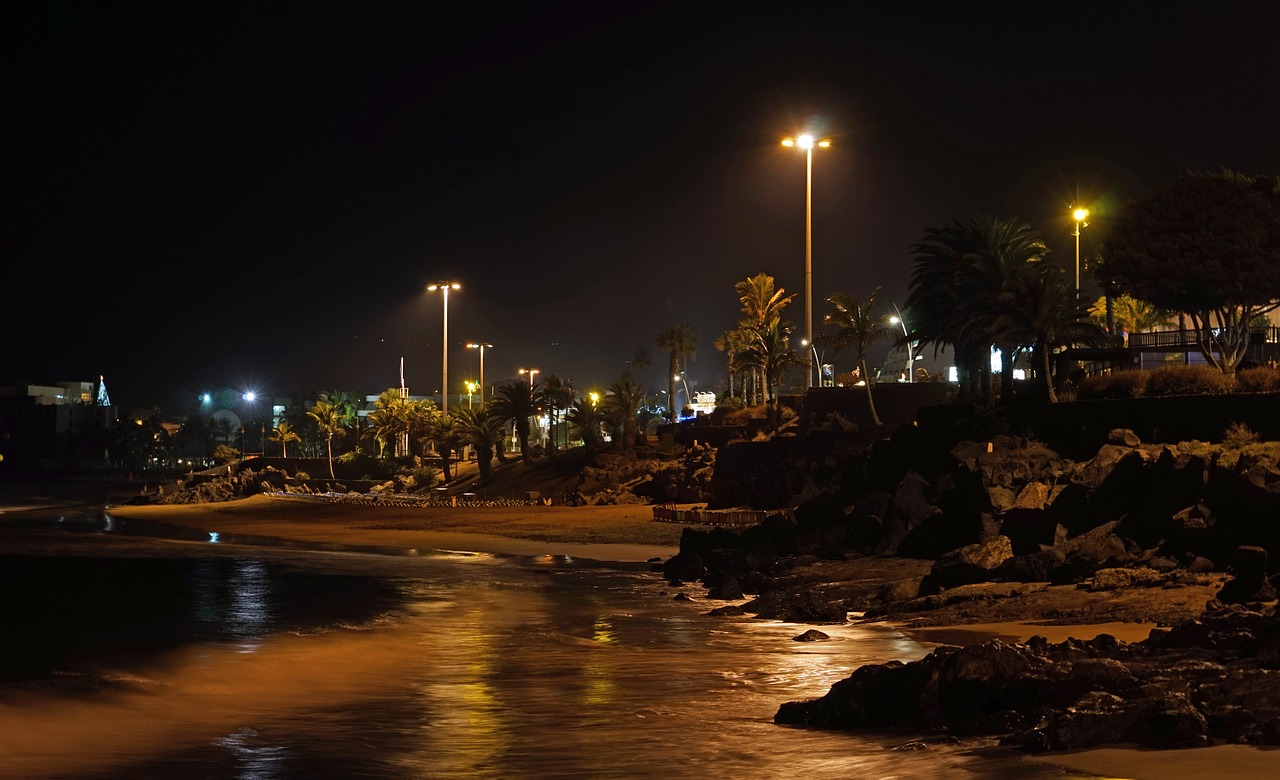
[{"left": 0, "top": 1, "right": 1280, "bottom": 411}]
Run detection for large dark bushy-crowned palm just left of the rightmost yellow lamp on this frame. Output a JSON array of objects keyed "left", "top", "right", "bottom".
[{"left": 906, "top": 216, "right": 1048, "bottom": 396}]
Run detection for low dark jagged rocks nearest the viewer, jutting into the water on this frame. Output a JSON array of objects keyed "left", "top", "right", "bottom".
[{"left": 774, "top": 602, "right": 1280, "bottom": 751}]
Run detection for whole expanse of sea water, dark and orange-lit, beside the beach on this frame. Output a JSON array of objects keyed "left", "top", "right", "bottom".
[{"left": 0, "top": 504, "right": 1068, "bottom": 780}]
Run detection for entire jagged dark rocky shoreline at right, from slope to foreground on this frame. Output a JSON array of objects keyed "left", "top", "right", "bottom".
[{"left": 657, "top": 429, "right": 1280, "bottom": 752}]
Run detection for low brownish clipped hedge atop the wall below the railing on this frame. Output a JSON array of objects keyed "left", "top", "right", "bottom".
[{"left": 1076, "top": 365, "right": 1280, "bottom": 401}]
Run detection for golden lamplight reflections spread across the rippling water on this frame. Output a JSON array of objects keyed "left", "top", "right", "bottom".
[{"left": 0, "top": 522, "right": 1061, "bottom": 780}]
